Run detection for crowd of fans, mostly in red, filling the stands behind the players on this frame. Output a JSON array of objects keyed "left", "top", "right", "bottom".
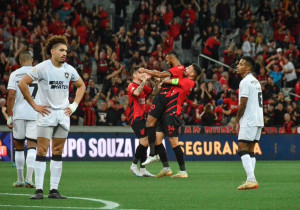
[{"left": 0, "top": 0, "right": 300, "bottom": 133}]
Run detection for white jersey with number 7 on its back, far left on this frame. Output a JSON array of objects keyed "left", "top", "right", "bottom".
[{"left": 7, "top": 66, "right": 39, "bottom": 120}]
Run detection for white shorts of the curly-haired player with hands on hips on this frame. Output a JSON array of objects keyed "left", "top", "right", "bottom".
[{"left": 37, "top": 109, "right": 70, "bottom": 131}]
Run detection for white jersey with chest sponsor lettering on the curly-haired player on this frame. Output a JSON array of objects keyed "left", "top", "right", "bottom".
[{"left": 28, "top": 59, "right": 79, "bottom": 109}]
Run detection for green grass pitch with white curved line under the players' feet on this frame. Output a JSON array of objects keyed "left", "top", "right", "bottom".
[{"left": 0, "top": 161, "right": 300, "bottom": 210}]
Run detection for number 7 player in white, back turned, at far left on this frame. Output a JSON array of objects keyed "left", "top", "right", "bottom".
[{"left": 7, "top": 51, "right": 38, "bottom": 188}]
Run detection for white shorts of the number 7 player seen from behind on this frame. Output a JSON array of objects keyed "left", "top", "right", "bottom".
[{"left": 13, "top": 120, "right": 37, "bottom": 140}]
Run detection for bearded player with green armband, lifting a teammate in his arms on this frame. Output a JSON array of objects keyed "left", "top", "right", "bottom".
[{"left": 139, "top": 64, "right": 201, "bottom": 178}]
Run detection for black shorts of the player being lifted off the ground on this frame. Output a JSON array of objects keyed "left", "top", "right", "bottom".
[{"left": 148, "top": 93, "right": 166, "bottom": 119}]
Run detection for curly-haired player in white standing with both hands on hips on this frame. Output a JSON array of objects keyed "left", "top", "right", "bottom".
[{"left": 19, "top": 36, "right": 86, "bottom": 199}]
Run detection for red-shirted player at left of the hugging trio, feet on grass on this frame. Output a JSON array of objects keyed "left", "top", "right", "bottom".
[{"left": 127, "top": 67, "right": 154, "bottom": 177}]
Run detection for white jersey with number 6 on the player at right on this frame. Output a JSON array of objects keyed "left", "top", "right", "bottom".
[{"left": 239, "top": 74, "right": 264, "bottom": 127}]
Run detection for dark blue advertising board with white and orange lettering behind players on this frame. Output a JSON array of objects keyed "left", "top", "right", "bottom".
[{"left": 0, "top": 133, "right": 300, "bottom": 161}]
